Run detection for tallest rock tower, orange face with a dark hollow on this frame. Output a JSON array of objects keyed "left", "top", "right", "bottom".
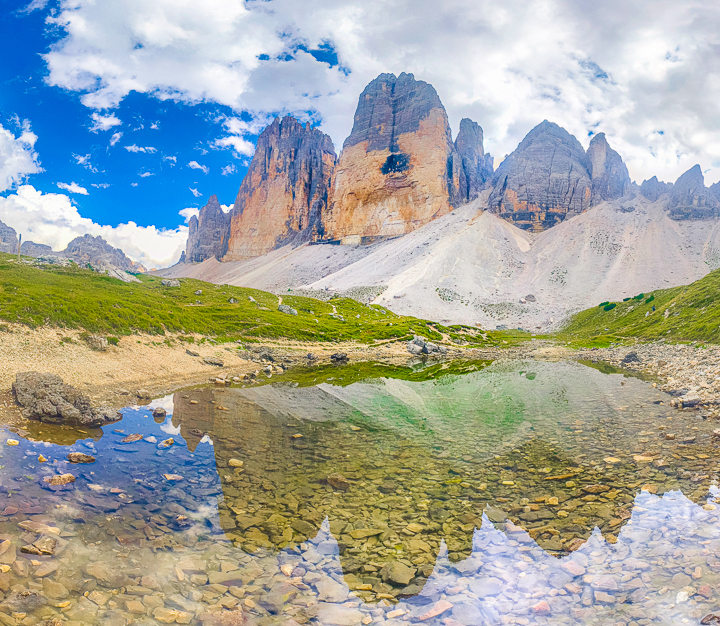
[{"left": 325, "top": 73, "right": 476, "bottom": 243}]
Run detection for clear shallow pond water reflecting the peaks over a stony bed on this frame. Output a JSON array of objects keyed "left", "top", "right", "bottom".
[{"left": 0, "top": 361, "right": 720, "bottom": 626}]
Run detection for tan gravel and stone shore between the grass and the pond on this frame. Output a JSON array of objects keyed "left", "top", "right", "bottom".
[{"left": 0, "top": 325, "right": 720, "bottom": 424}]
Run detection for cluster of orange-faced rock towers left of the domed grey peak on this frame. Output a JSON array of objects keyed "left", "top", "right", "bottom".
[{"left": 184, "top": 73, "right": 493, "bottom": 263}]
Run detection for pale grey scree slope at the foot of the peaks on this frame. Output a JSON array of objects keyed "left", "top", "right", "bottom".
[{"left": 162, "top": 192, "right": 720, "bottom": 332}]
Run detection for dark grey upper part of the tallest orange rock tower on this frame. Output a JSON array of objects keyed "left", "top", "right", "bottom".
[{"left": 343, "top": 72, "right": 450, "bottom": 153}]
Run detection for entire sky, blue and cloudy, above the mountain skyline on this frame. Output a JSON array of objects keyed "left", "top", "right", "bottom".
[{"left": 0, "top": 0, "right": 720, "bottom": 267}]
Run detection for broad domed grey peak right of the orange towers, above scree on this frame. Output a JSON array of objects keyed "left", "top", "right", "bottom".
[{"left": 488, "top": 120, "right": 592, "bottom": 231}]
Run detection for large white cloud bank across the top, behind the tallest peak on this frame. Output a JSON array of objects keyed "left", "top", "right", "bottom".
[{"left": 38, "top": 0, "right": 720, "bottom": 180}]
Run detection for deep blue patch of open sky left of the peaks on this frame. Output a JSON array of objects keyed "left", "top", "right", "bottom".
[{"left": 0, "top": 0, "right": 255, "bottom": 228}]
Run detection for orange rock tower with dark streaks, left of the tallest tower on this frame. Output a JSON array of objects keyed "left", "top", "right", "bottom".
[{"left": 223, "top": 117, "right": 337, "bottom": 261}]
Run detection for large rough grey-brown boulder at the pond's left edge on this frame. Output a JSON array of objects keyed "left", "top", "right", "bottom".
[{"left": 12, "top": 372, "right": 122, "bottom": 428}]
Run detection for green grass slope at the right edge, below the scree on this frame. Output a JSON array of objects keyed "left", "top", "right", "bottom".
[{"left": 558, "top": 270, "right": 720, "bottom": 346}]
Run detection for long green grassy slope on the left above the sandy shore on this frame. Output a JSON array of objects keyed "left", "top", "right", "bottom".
[{"left": 0, "top": 254, "right": 513, "bottom": 345}]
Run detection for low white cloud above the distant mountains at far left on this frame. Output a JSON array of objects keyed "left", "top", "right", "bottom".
[{"left": 0, "top": 185, "right": 188, "bottom": 268}]
